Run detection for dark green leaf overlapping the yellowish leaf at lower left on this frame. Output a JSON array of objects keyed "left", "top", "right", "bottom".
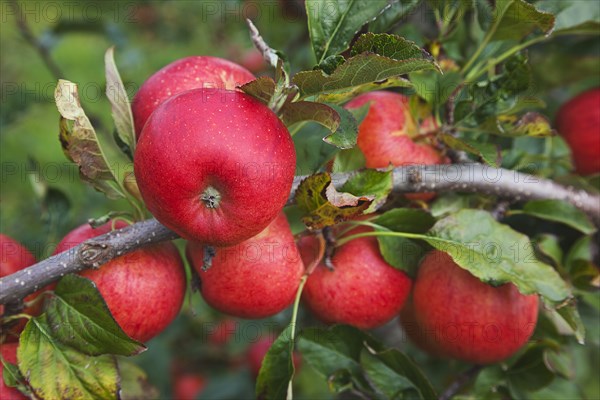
[{"left": 46, "top": 275, "right": 146, "bottom": 356}]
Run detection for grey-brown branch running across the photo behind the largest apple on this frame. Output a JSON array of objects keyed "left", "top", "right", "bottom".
[{"left": 0, "top": 163, "right": 600, "bottom": 304}]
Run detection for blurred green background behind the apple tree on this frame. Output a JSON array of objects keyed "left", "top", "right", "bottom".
[{"left": 0, "top": 0, "right": 600, "bottom": 399}]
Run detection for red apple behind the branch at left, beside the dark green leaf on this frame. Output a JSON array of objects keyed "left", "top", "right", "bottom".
[{"left": 54, "top": 222, "right": 186, "bottom": 342}]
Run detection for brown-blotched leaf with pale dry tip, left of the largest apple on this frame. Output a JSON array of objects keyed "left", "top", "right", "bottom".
[{"left": 54, "top": 79, "right": 125, "bottom": 199}]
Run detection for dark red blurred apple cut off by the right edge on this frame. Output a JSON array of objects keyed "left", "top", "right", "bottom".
[{"left": 556, "top": 88, "right": 600, "bottom": 175}]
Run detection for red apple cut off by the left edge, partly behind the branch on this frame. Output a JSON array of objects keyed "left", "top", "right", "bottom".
[{"left": 0, "top": 234, "right": 42, "bottom": 340}]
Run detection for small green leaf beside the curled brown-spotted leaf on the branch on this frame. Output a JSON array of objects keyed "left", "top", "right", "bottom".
[{"left": 340, "top": 169, "right": 393, "bottom": 214}]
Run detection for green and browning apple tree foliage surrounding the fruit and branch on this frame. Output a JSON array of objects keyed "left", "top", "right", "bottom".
[{"left": 3, "top": 0, "right": 600, "bottom": 399}]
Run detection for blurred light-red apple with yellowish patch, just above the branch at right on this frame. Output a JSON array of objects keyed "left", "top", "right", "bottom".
[{"left": 345, "top": 91, "right": 447, "bottom": 200}]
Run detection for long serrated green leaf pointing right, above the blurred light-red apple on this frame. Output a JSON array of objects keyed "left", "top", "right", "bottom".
[{"left": 292, "top": 39, "right": 437, "bottom": 97}]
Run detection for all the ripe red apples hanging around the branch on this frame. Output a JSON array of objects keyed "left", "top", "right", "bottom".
[{"left": 10, "top": 56, "right": 600, "bottom": 395}]
